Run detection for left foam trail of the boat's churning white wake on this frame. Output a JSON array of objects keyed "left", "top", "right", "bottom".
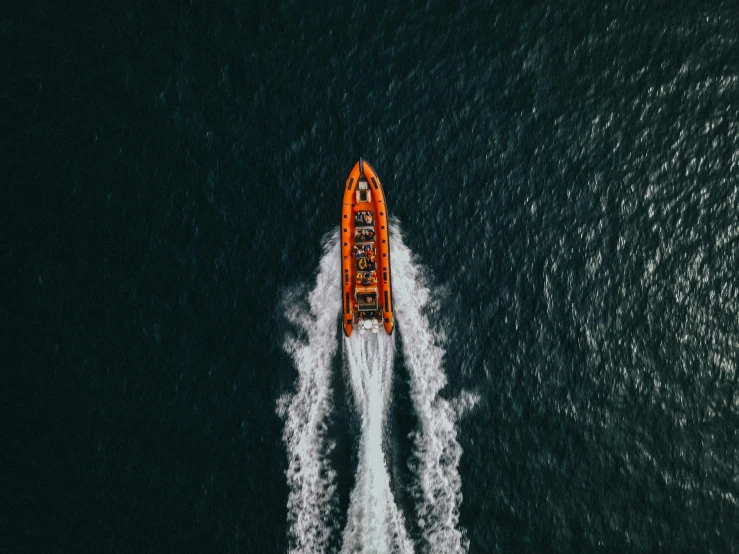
[{"left": 278, "top": 230, "right": 341, "bottom": 554}]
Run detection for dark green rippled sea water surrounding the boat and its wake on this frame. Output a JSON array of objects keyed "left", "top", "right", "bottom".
[{"left": 5, "top": 0, "right": 739, "bottom": 553}]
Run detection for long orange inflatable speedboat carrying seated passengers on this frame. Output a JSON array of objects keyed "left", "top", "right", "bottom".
[{"left": 341, "top": 158, "right": 395, "bottom": 337}]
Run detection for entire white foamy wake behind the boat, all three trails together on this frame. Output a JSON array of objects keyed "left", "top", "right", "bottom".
[{"left": 278, "top": 224, "right": 467, "bottom": 554}]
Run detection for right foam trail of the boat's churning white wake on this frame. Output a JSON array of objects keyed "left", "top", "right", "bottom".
[{"left": 390, "top": 222, "right": 468, "bottom": 554}]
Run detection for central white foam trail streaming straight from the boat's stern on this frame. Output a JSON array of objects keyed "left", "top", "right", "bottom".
[{"left": 342, "top": 331, "right": 413, "bottom": 554}]
